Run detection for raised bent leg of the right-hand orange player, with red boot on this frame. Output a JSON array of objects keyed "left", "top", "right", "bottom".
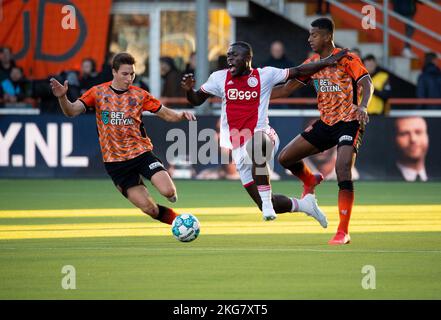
[{"left": 279, "top": 134, "right": 323, "bottom": 198}]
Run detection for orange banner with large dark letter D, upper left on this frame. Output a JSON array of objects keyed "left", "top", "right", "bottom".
[{"left": 0, "top": 0, "right": 112, "bottom": 79}]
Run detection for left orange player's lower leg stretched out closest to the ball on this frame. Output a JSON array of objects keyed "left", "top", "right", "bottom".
[{"left": 122, "top": 185, "right": 177, "bottom": 224}]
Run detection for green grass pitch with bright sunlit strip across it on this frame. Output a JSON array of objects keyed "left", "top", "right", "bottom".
[{"left": 0, "top": 180, "right": 441, "bottom": 300}]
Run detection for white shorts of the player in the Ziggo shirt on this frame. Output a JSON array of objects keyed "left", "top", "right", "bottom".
[{"left": 231, "top": 128, "right": 280, "bottom": 187}]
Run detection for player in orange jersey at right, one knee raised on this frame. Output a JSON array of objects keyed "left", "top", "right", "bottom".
[{"left": 271, "top": 18, "right": 373, "bottom": 244}]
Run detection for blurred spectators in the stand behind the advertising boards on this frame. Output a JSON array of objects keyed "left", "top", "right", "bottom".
[{"left": 0, "top": 41, "right": 441, "bottom": 114}]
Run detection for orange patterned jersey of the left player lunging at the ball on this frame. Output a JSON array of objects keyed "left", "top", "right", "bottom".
[{"left": 80, "top": 82, "right": 161, "bottom": 162}]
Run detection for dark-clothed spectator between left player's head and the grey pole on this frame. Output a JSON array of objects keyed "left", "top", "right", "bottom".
[{"left": 160, "top": 56, "right": 185, "bottom": 97}]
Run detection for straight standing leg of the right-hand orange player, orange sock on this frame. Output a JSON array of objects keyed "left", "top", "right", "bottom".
[{"left": 329, "top": 145, "right": 356, "bottom": 245}]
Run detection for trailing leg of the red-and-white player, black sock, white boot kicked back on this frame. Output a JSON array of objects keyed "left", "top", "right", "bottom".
[{"left": 245, "top": 183, "right": 328, "bottom": 228}]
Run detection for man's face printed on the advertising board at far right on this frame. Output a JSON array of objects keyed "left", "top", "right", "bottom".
[{"left": 395, "top": 117, "right": 429, "bottom": 161}]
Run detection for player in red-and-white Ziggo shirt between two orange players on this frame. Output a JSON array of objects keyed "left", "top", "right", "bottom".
[{"left": 181, "top": 41, "right": 346, "bottom": 224}]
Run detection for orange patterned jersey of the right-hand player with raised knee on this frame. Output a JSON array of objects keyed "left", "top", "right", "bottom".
[{"left": 297, "top": 48, "right": 369, "bottom": 126}]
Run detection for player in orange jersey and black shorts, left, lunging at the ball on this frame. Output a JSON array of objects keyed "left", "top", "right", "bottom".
[{"left": 50, "top": 53, "right": 195, "bottom": 224}]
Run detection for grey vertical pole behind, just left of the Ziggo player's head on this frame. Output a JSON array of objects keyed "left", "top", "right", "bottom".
[{"left": 195, "top": 0, "right": 210, "bottom": 114}]
